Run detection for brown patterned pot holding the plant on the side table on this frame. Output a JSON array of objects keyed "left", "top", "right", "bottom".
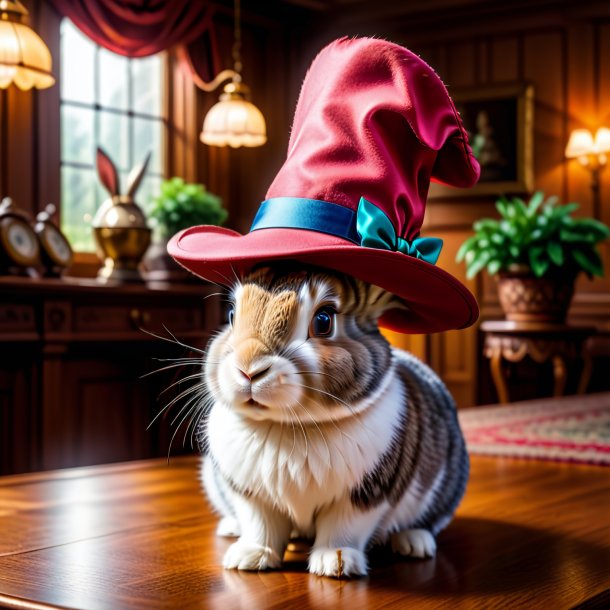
[{"left": 498, "top": 273, "right": 575, "bottom": 323}]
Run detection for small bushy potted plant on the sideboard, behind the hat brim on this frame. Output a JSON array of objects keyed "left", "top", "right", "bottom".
[{"left": 145, "top": 177, "right": 228, "bottom": 281}]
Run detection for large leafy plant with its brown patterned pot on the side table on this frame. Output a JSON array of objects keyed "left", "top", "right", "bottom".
[{"left": 456, "top": 191, "right": 610, "bottom": 322}]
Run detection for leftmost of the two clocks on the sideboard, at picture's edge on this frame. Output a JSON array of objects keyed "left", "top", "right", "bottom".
[{"left": 0, "top": 197, "right": 40, "bottom": 277}]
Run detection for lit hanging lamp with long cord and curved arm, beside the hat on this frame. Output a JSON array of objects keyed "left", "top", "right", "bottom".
[{"left": 197, "top": 0, "right": 267, "bottom": 148}]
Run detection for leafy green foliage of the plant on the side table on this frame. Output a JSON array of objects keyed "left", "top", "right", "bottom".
[{"left": 456, "top": 191, "right": 610, "bottom": 278}]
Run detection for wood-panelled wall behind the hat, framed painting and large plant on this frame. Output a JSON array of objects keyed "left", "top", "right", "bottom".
[{"left": 302, "top": 0, "right": 610, "bottom": 405}]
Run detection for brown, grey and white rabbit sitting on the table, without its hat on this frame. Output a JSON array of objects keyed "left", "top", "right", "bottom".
[{"left": 197, "top": 265, "right": 469, "bottom": 578}]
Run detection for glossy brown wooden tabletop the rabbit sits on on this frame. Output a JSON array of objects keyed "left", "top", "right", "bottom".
[{"left": 0, "top": 457, "right": 610, "bottom": 610}]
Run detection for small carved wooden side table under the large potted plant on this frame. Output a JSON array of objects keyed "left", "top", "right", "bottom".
[{"left": 481, "top": 320, "right": 596, "bottom": 403}]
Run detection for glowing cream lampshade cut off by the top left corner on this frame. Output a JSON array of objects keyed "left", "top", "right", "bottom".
[{"left": 0, "top": 0, "right": 55, "bottom": 91}]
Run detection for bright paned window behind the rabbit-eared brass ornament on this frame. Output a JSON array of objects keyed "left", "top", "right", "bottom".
[{"left": 60, "top": 19, "right": 167, "bottom": 251}]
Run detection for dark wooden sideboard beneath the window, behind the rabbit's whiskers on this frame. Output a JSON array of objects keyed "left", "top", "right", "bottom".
[{"left": 0, "top": 277, "right": 219, "bottom": 474}]
